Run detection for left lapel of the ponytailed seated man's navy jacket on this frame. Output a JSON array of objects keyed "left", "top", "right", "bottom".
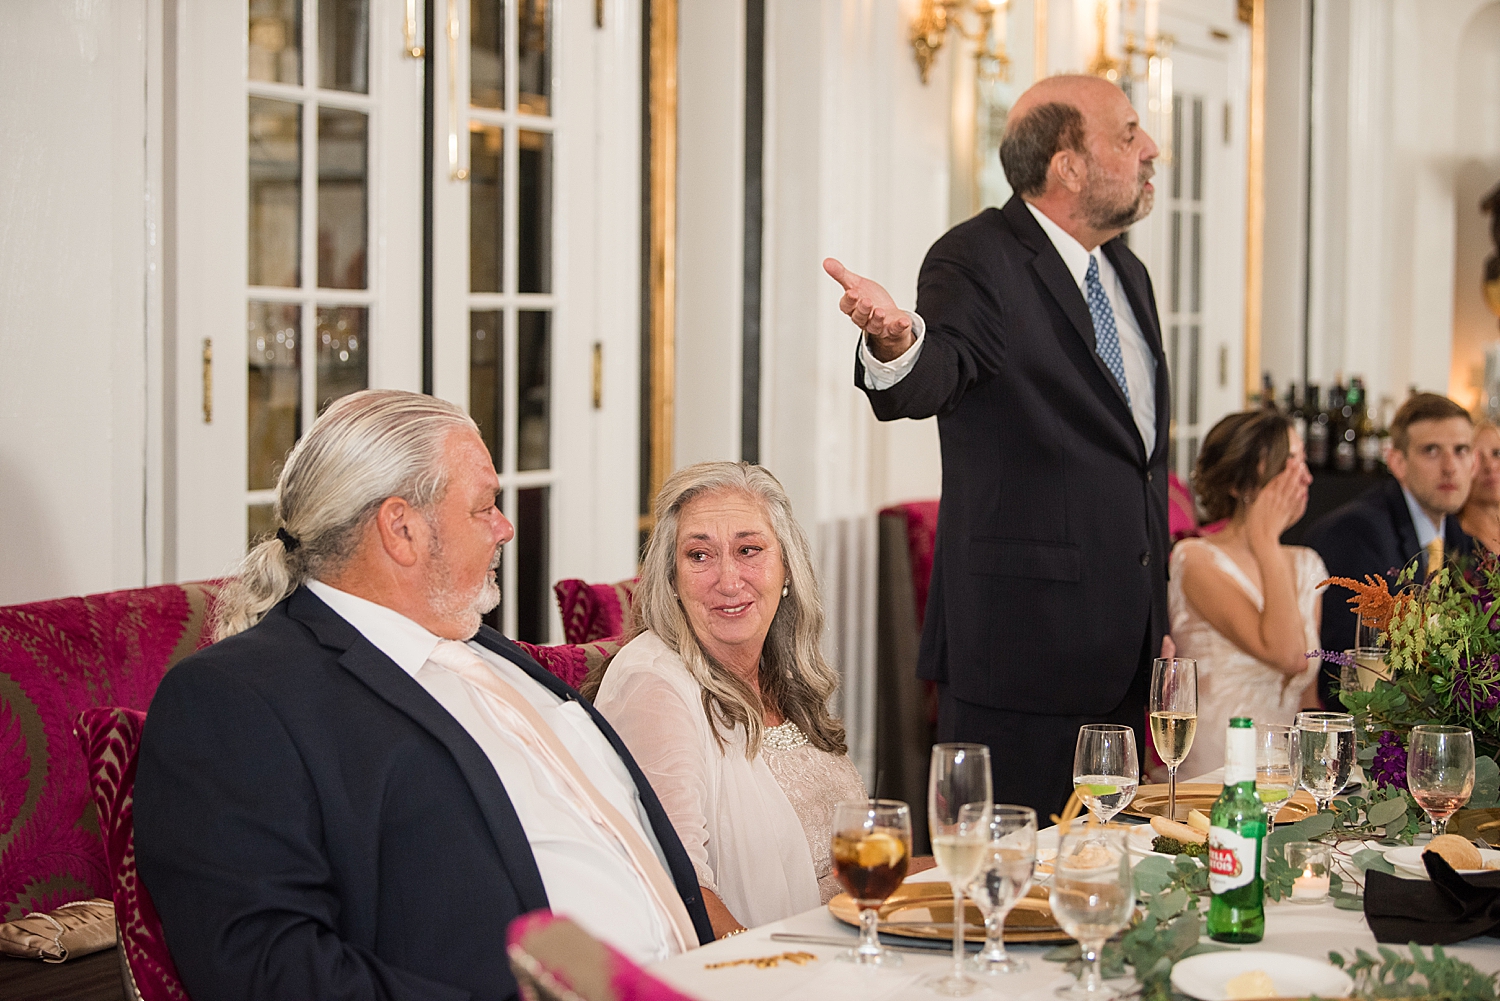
[{"left": 287, "top": 588, "right": 552, "bottom": 911}]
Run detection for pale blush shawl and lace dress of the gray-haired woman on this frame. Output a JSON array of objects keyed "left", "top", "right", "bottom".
[{"left": 594, "top": 632, "right": 864, "bottom": 927}]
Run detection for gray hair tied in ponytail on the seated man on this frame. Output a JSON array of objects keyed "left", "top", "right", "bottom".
[{"left": 213, "top": 389, "right": 476, "bottom": 639}]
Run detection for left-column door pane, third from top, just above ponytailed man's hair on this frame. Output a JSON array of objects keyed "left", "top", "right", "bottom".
[{"left": 248, "top": 302, "right": 302, "bottom": 491}]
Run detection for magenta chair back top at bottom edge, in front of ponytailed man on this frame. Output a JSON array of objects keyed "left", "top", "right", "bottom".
[{"left": 506, "top": 911, "right": 693, "bottom": 1001}]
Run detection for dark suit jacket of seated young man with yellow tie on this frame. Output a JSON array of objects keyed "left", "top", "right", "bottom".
[{"left": 1302, "top": 480, "right": 1473, "bottom": 657}]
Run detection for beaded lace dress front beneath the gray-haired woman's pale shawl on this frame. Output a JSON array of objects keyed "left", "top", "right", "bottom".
[{"left": 761, "top": 722, "right": 866, "bottom": 903}]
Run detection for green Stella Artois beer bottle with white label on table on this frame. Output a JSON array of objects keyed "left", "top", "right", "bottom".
[{"left": 1209, "top": 716, "right": 1266, "bottom": 942}]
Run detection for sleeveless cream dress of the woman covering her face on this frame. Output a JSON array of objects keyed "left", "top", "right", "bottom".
[{"left": 1167, "top": 539, "right": 1328, "bottom": 777}]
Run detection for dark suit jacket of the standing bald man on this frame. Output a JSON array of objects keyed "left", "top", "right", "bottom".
[{"left": 855, "top": 198, "right": 1170, "bottom": 714}]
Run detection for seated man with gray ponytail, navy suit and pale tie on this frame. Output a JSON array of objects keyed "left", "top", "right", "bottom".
[{"left": 135, "top": 390, "right": 713, "bottom": 1001}]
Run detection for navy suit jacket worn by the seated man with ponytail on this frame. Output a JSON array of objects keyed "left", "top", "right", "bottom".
[{"left": 135, "top": 588, "right": 713, "bottom": 1001}]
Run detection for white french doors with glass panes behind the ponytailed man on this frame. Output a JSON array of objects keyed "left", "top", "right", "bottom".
[{"left": 170, "top": 0, "right": 641, "bottom": 642}]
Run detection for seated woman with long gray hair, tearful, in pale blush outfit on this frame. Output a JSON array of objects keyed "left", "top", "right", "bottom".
[{"left": 596, "top": 462, "right": 864, "bottom": 936}]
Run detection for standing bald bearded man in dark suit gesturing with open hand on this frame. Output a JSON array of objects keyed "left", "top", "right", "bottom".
[{"left": 824, "top": 77, "right": 1170, "bottom": 816}]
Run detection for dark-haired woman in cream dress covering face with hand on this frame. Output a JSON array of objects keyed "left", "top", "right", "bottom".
[{"left": 1167, "top": 410, "right": 1328, "bottom": 774}]
